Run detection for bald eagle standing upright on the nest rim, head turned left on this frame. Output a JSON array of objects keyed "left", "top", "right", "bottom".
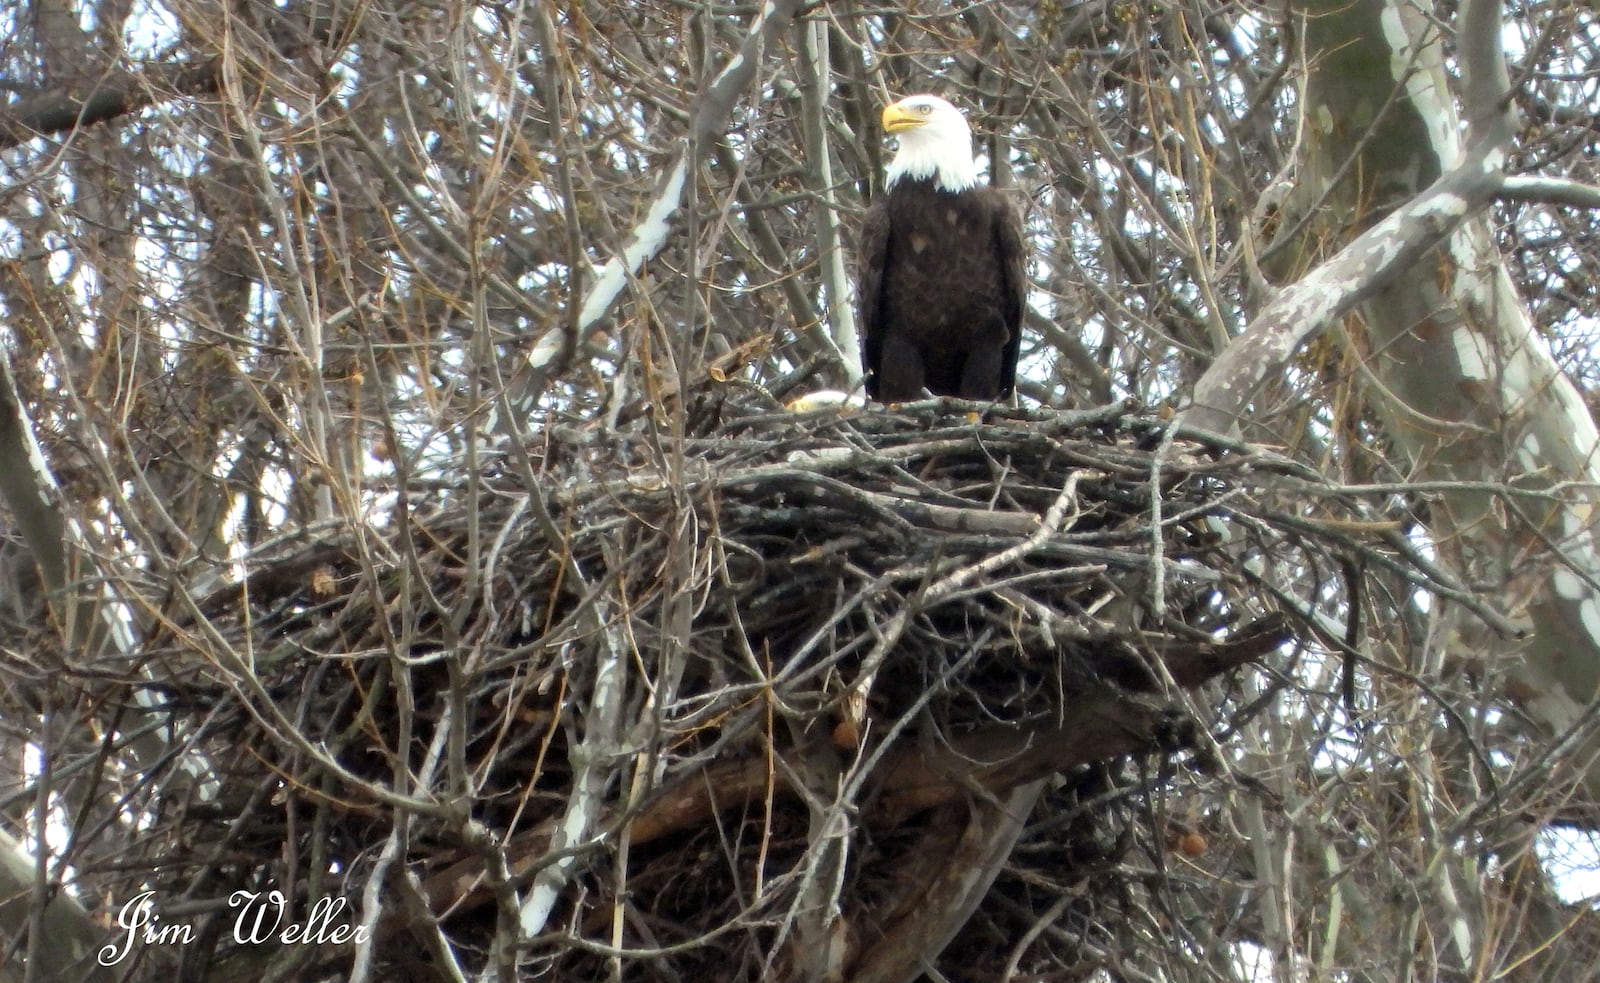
[{"left": 856, "top": 96, "right": 1027, "bottom": 403}]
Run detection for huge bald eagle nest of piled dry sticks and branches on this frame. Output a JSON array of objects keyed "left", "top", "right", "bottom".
[{"left": 50, "top": 402, "right": 1472, "bottom": 980}]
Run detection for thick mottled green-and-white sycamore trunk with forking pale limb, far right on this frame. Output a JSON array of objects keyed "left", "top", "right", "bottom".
[{"left": 1184, "top": 0, "right": 1600, "bottom": 791}]
